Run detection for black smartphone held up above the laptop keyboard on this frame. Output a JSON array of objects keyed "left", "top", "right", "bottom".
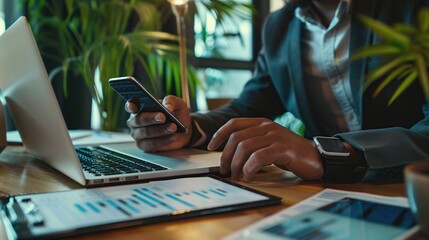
[{"left": 109, "top": 76, "right": 188, "bottom": 133}]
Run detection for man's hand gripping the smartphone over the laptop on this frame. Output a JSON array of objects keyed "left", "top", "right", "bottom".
[{"left": 125, "top": 96, "right": 192, "bottom": 152}]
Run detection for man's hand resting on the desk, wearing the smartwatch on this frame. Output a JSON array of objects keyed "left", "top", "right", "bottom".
[{"left": 208, "top": 118, "right": 323, "bottom": 181}]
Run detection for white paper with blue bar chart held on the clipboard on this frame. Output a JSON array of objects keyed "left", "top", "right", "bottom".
[{"left": 16, "top": 177, "right": 268, "bottom": 235}]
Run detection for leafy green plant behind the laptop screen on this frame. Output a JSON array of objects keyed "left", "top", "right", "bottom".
[{"left": 24, "top": 0, "right": 251, "bottom": 130}]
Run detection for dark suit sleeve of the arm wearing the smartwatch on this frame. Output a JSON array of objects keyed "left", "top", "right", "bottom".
[{"left": 338, "top": 105, "right": 429, "bottom": 180}]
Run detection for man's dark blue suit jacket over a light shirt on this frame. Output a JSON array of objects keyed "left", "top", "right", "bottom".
[{"left": 193, "top": 0, "right": 429, "bottom": 178}]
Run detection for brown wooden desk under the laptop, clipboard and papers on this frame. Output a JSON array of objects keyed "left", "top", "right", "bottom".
[{"left": 0, "top": 147, "right": 405, "bottom": 240}]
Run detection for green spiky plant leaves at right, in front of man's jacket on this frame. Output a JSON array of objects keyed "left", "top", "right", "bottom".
[{"left": 351, "top": 8, "right": 429, "bottom": 105}]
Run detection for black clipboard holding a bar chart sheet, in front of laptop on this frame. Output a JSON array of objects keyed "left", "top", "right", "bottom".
[{"left": 0, "top": 176, "right": 282, "bottom": 239}]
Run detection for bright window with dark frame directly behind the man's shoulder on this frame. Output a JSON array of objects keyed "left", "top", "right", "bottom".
[{"left": 191, "top": 0, "right": 284, "bottom": 110}]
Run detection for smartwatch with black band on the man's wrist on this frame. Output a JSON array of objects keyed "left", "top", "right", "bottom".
[{"left": 313, "top": 136, "right": 368, "bottom": 183}]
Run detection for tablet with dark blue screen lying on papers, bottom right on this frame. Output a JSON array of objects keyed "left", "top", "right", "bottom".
[{"left": 257, "top": 198, "right": 416, "bottom": 240}]
